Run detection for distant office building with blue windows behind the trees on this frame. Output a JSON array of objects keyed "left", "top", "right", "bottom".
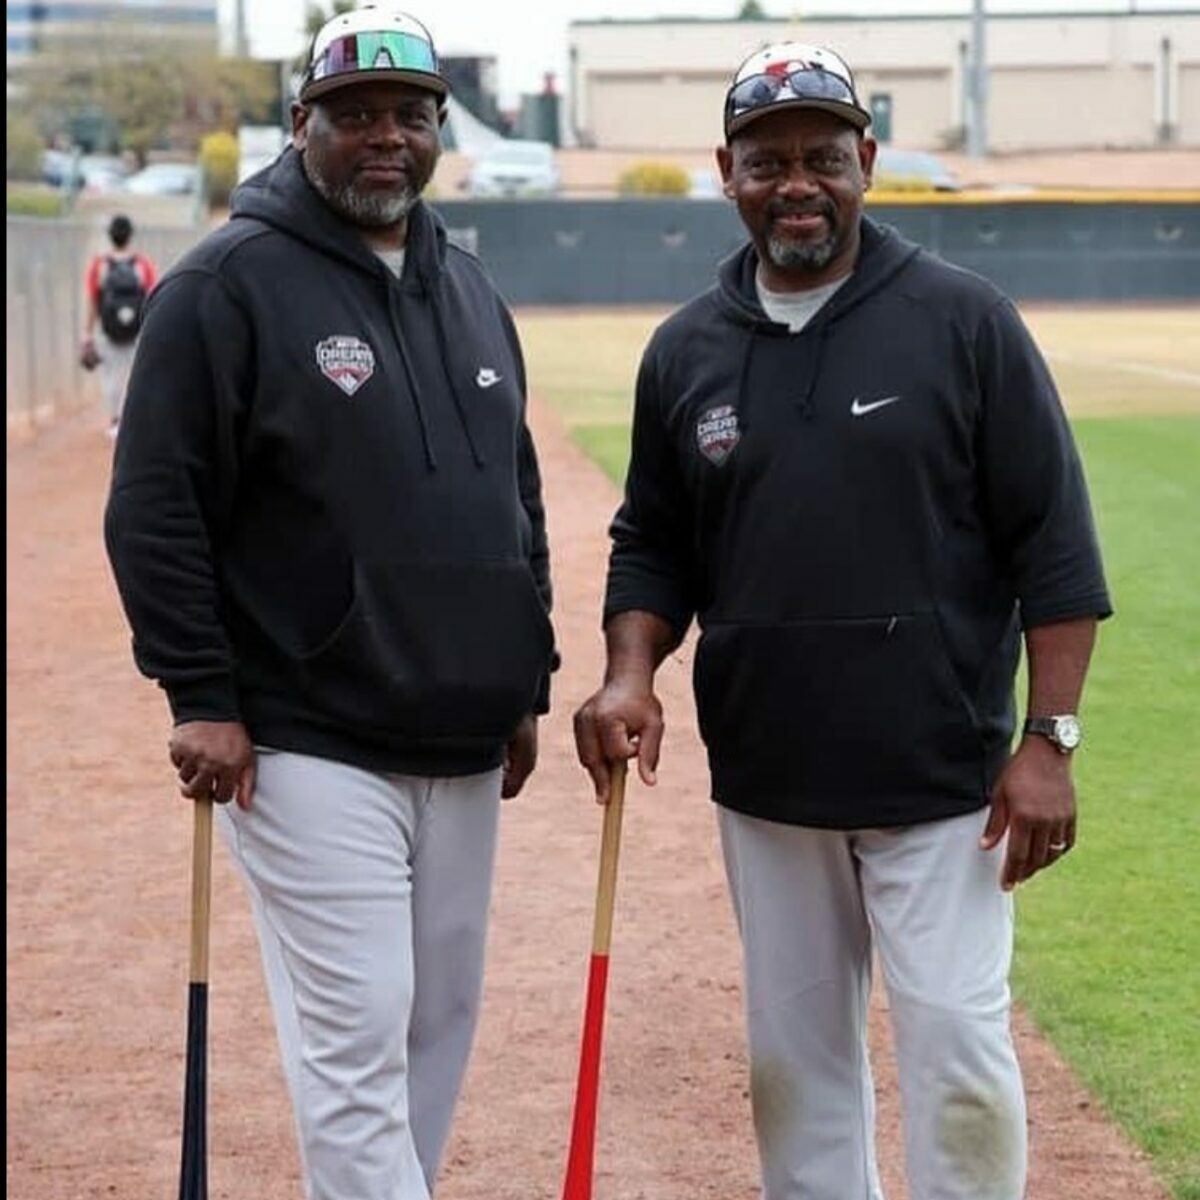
[{"left": 5, "top": 0, "right": 218, "bottom": 73}]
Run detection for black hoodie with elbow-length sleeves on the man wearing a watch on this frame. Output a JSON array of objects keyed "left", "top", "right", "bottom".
[{"left": 605, "top": 218, "right": 1110, "bottom": 828}]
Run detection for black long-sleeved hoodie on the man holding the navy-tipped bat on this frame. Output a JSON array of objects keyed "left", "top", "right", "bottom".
[{"left": 106, "top": 150, "right": 554, "bottom": 774}]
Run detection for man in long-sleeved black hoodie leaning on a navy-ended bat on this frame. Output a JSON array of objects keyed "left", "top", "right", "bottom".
[{"left": 106, "top": 8, "right": 556, "bottom": 1200}]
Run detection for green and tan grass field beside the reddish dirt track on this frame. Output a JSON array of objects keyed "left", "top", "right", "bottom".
[{"left": 518, "top": 307, "right": 1200, "bottom": 1200}]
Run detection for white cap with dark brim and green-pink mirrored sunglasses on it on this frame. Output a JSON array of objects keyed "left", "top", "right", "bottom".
[{"left": 300, "top": 5, "right": 450, "bottom": 103}]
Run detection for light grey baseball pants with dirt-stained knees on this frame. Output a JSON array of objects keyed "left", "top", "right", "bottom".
[{"left": 718, "top": 808, "right": 1026, "bottom": 1200}]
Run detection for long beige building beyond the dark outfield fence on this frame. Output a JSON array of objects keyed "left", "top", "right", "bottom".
[{"left": 568, "top": 9, "right": 1200, "bottom": 152}]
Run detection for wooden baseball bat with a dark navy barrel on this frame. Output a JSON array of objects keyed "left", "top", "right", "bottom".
[{"left": 179, "top": 799, "right": 212, "bottom": 1200}]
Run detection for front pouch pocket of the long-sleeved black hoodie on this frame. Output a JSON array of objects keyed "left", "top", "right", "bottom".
[{"left": 299, "top": 562, "right": 553, "bottom": 742}]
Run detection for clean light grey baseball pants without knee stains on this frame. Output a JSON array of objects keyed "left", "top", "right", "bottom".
[{"left": 220, "top": 749, "right": 500, "bottom": 1200}]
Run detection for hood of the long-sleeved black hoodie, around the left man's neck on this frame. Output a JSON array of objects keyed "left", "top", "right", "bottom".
[{"left": 229, "top": 146, "right": 446, "bottom": 290}]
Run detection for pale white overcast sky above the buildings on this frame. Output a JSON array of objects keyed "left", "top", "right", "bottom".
[{"left": 226, "top": 0, "right": 1198, "bottom": 107}]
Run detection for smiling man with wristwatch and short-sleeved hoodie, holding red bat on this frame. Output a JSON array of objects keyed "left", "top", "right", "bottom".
[{"left": 576, "top": 43, "right": 1110, "bottom": 1200}]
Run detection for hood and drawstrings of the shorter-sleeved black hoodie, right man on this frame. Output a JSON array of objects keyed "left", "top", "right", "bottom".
[{"left": 716, "top": 216, "right": 920, "bottom": 428}]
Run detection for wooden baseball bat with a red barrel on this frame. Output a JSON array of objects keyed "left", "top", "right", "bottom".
[{"left": 563, "top": 760, "right": 625, "bottom": 1200}]
